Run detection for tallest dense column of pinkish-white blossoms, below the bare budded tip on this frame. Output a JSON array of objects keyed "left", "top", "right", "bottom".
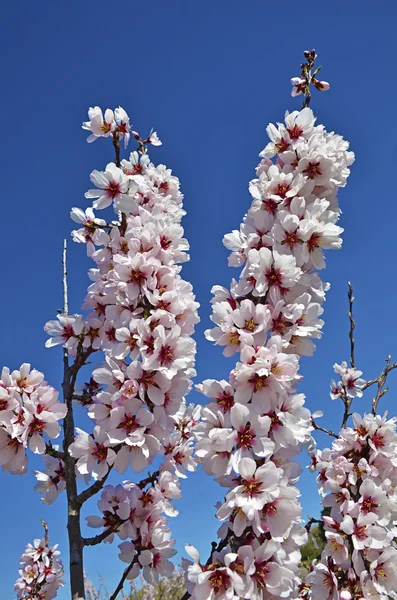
[{"left": 188, "top": 108, "right": 353, "bottom": 600}]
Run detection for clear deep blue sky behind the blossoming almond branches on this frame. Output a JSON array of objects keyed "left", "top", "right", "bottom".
[{"left": 0, "top": 0, "right": 397, "bottom": 600}]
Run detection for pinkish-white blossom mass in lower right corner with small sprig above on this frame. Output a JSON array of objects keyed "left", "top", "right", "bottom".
[{"left": 301, "top": 363, "right": 397, "bottom": 600}]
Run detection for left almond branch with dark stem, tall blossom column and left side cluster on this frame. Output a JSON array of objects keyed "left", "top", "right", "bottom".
[{"left": 0, "top": 107, "right": 199, "bottom": 600}]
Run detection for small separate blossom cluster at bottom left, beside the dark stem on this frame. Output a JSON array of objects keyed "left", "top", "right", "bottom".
[{"left": 15, "top": 529, "right": 64, "bottom": 600}]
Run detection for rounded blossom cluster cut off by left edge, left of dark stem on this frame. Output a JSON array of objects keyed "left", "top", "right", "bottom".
[{"left": 0, "top": 363, "right": 66, "bottom": 475}]
